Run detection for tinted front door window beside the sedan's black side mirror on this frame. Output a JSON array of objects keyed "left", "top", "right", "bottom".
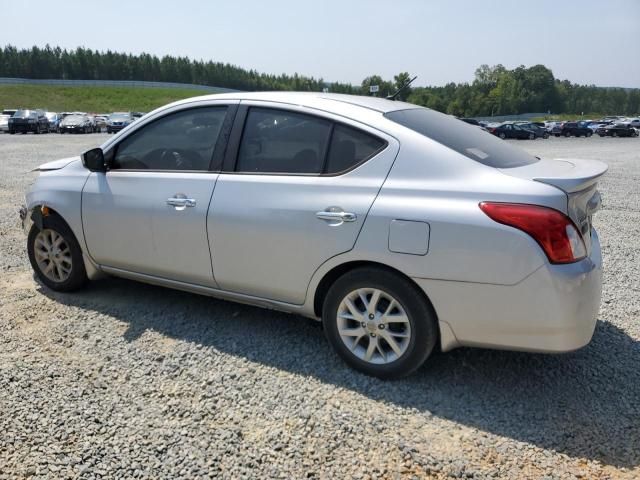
[{"left": 112, "top": 107, "right": 227, "bottom": 171}]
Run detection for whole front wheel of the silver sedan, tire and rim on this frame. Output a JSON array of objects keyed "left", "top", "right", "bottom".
[{"left": 27, "top": 215, "right": 87, "bottom": 292}]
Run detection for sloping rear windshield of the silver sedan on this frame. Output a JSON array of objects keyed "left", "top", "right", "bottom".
[{"left": 385, "top": 108, "right": 538, "bottom": 168}]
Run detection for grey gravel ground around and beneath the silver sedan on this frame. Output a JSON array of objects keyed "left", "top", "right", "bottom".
[{"left": 0, "top": 135, "right": 640, "bottom": 479}]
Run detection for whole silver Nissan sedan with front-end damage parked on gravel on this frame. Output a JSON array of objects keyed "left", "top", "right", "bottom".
[{"left": 21, "top": 93, "right": 607, "bottom": 378}]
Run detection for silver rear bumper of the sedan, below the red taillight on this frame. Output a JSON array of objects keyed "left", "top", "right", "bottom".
[{"left": 415, "top": 230, "right": 602, "bottom": 352}]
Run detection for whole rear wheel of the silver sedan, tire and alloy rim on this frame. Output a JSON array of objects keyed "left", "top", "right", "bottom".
[{"left": 322, "top": 268, "right": 438, "bottom": 378}]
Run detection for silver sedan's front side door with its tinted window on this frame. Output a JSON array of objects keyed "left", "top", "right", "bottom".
[{"left": 82, "top": 106, "right": 232, "bottom": 287}]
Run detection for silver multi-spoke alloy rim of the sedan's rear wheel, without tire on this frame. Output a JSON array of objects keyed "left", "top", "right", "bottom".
[{"left": 336, "top": 288, "right": 412, "bottom": 365}]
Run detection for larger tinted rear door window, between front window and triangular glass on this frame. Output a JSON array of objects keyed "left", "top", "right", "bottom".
[{"left": 236, "top": 108, "right": 331, "bottom": 174}]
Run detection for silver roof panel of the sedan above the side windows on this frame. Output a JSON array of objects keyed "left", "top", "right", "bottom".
[{"left": 165, "top": 92, "right": 421, "bottom": 113}]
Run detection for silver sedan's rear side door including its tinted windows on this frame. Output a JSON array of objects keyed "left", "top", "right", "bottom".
[{"left": 207, "top": 102, "right": 399, "bottom": 304}]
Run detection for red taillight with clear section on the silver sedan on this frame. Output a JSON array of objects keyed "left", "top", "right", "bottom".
[{"left": 480, "top": 202, "right": 587, "bottom": 263}]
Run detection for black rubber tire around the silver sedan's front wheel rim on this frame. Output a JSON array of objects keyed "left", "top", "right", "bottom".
[{"left": 27, "top": 215, "right": 88, "bottom": 292}]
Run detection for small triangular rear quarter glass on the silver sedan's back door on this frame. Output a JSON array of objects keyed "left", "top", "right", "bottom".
[{"left": 325, "top": 125, "right": 385, "bottom": 174}]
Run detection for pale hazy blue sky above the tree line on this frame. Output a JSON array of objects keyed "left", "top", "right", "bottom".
[{"left": 0, "top": 0, "right": 640, "bottom": 87}]
